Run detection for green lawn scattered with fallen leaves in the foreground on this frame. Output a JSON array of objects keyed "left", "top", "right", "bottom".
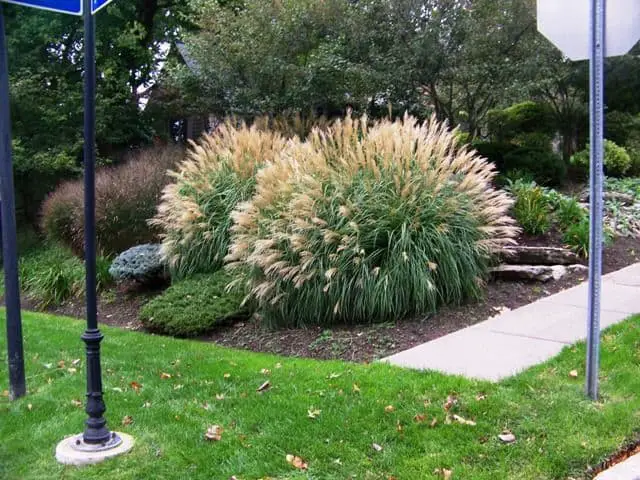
[{"left": 0, "top": 314, "right": 640, "bottom": 480}]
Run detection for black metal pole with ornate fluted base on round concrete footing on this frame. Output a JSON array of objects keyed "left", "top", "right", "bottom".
[{"left": 82, "top": 0, "right": 111, "bottom": 445}]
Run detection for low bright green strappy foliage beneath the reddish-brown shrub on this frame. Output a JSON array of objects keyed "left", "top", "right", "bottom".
[{"left": 20, "top": 245, "right": 112, "bottom": 307}]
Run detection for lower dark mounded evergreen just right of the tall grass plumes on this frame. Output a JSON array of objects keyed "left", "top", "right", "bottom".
[{"left": 504, "top": 147, "right": 567, "bottom": 185}]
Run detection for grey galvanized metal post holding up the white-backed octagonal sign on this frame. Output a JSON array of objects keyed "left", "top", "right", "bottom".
[{"left": 585, "top": 0, "right": 606, "bottom": 400}]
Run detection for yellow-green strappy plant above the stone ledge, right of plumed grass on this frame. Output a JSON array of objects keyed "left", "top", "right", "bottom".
[{"left": 509, "top": 181, "right": 551, "bottom": 235}]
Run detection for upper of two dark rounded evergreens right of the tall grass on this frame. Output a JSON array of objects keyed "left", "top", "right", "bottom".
[{"left": 487, "top": 101, "right": 555, "bottom": 142}]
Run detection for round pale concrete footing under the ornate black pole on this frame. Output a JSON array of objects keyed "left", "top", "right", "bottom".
[{"left": 56, "top": 432, "right": 134, "bottom": 466}]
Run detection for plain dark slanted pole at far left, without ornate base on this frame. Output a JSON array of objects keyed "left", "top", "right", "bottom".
[{"left": 0, "top": 2, "right": 27, "bottom": 399}]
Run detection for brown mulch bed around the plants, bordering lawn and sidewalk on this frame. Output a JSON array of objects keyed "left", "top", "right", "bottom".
[{"left": 18, "top": 232, "right": 640, "bottom": 362}]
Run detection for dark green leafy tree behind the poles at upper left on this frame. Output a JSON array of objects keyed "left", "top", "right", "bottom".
[{"left": 6, "top": 0, "right": 190, "bottom": 222}]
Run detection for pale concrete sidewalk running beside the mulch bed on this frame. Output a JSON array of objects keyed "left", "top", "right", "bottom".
[{"left": 383, "top": 263, "right": 640, "bottom": 381}]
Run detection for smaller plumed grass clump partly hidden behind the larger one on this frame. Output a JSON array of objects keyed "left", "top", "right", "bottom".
[{"left": 151, "top": 120, "right": 286, "bottom": 278}]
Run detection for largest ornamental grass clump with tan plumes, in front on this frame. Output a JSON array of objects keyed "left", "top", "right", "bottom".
[{"left": 227, "top": 117, "right": 518, "bottom": 326}]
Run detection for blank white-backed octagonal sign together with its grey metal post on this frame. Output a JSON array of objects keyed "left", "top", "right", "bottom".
[{"left": 538, "top": 0, "right": 640, "bottom": 400}]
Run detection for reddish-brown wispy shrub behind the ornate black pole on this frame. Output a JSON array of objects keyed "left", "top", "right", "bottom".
[{"left": 41, "top": 147, "right": 182, "bottom": 255}]
